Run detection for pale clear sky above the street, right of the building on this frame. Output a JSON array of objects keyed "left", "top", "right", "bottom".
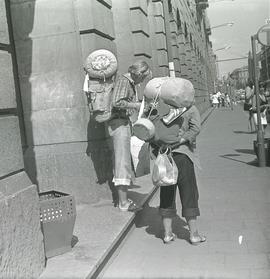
[{"left": 207, "top": 0, "right": 270, "bottom": 77}]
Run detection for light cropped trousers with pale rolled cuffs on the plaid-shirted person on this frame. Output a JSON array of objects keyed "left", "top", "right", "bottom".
[{"left": 108, "top": 118, "right": 132, "bottom": 186}]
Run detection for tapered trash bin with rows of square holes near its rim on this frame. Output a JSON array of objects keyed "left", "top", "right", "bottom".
[{"left": 39, "top": 191, "right": 76, "bottom": 258}]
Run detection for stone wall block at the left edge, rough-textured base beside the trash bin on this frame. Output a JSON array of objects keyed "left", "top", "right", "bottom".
[{"left": 0, "top": 0, "right": 45, "bottom": 278}]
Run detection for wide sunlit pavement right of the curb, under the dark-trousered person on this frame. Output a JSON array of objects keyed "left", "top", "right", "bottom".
[{"left": 99, "top": 105, "right": 270, "bottom": 279}]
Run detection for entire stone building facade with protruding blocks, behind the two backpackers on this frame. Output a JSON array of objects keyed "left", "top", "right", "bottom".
[{"left": 0, "top": 0, "right": 215, "bottom": 278}]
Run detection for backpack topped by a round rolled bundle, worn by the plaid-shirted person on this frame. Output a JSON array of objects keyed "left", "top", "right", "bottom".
[{"left": 83, "top": 49, "right": 118, "bottom": 122}]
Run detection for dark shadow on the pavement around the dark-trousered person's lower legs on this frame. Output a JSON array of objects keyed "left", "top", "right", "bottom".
[{"left": 135, "top": 204, "right": 189, "bottom": 242}]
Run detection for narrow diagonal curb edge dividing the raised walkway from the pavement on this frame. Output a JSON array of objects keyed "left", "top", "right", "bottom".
[{"left": 89, "top": 107, "right": 214, "bottom": 279}]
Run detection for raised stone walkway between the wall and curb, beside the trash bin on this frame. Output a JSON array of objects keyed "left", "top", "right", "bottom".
[{"left": 40, "top": 108, "right": 212, "bottom": 279}]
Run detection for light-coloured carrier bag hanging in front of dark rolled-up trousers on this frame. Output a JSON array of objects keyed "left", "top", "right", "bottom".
[{"left": 152, "top": 147, "right": 178, "bottom": 187}]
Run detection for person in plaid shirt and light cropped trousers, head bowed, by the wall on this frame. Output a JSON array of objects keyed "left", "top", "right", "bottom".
[{"left": 108, "top": 60, "right": 151, "bottom": 212}]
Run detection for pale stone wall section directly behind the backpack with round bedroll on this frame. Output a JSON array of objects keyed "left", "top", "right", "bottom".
[{"left": 11, "top": 0, "right": 116, "bottom": 206}]
